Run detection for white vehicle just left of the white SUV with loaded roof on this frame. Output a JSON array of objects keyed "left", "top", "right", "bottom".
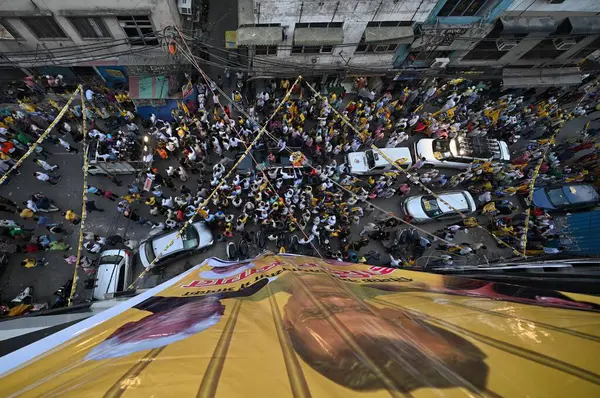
[{"left": 346, "top": 147, "right": 413, "bottom": 175}]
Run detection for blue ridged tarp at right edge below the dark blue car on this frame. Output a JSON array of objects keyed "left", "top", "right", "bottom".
[{"left": 554, "top": 210, "right": 600, "bottom": 256}]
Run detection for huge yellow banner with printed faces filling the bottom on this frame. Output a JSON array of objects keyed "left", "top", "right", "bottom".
[{"left": 0, "top": 255, "right": 600, "bottom": 397}]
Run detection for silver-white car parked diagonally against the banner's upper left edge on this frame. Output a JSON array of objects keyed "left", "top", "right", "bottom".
[{"left": 139, "top": 221, "right": 214, "bottom": 269}]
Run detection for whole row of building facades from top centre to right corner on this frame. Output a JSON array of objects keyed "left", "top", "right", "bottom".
[{"left": 237, "top": 0, "right": 600, "bottom": 84}]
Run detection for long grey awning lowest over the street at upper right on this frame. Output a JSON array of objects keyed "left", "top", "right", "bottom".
[{"left": 502, "top": 68, "right": 581, "bottom": 88}]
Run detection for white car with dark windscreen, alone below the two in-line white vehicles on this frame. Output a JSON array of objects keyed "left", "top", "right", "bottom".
[{"left": 402, "top": 191, "right": 477, "bottom": 223}]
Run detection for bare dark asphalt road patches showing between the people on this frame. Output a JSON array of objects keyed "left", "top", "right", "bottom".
[{"left": 0, "top": 93, "right": 595, "bottom": 302}]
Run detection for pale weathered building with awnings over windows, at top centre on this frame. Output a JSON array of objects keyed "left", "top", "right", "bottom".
[{"left": 237, "top": 0, "right": 438, "bottom": 79}]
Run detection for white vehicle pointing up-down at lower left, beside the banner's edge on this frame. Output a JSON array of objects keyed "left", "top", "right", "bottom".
[{"left": 92, "top": 249, "right": 133, "bottom": 300}]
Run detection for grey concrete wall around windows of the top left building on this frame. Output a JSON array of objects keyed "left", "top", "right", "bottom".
[{"left": 0, "top": 0, "right": 181, "bottom": 66}]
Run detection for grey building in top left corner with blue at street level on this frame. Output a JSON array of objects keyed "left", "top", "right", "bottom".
[{"left": 0, "top": 0, "right": 192, "bottom": 110}]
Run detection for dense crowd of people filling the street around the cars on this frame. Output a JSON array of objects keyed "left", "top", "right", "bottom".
[{"left": 0, "top": 71, "right": 600, "bottom": 304}]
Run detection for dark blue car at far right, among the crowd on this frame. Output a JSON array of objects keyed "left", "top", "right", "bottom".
[{"left": 533, "top": 184, "right": 600, "bottom": 212}]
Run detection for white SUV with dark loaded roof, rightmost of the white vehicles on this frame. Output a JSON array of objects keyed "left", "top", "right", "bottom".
[{"left": 414, "top": 136, "right": 510, "bottom": 169}]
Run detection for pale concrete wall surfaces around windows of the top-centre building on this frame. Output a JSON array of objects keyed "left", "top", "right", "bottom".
[{"left": 238, "top": 0, "right": 437, "bottom": 68}]
